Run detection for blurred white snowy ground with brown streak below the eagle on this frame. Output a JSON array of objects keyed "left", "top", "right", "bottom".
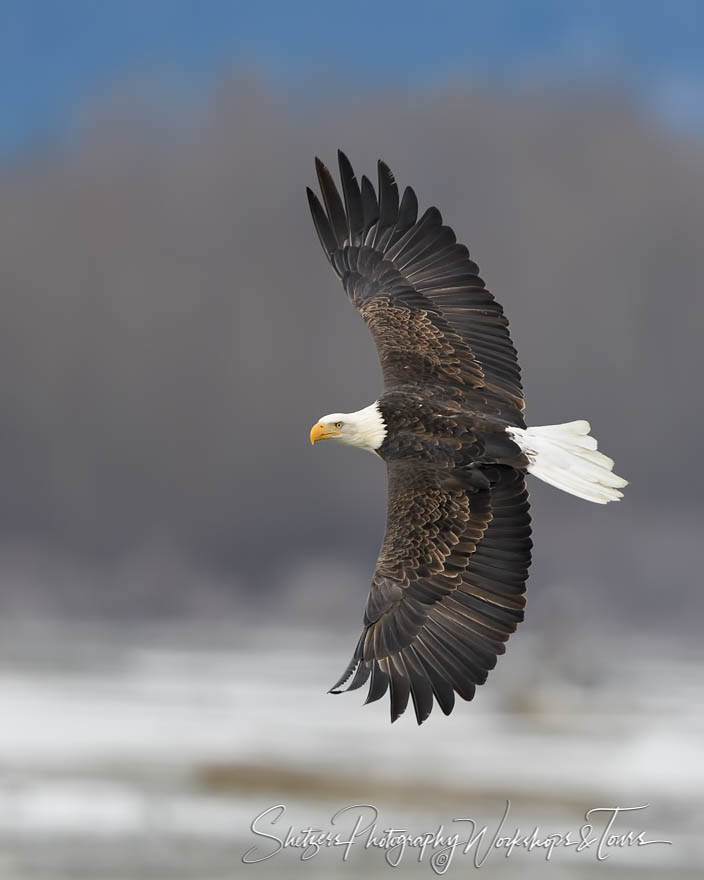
[{"left": 0, "top": 624, "right": 704, "bottom": 880}]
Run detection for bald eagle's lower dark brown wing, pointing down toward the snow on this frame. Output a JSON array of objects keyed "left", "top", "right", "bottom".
[{"left": 332, "top": 462, "right": 532, "bottom": 724}]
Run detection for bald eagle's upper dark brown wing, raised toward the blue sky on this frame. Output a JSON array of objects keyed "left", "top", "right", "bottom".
[{"left": 307, "top": 152, "right": 524, "bottom": 427}]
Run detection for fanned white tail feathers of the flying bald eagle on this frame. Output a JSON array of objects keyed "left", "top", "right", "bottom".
[{"left": 506, "top": 420, "right": 628, "bottom": 504}]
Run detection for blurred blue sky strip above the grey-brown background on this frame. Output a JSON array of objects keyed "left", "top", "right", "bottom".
[{"left": 0, "top": 0, "right": 704, "bottom": 153}]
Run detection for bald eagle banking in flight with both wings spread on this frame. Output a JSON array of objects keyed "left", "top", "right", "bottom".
[{"left": 307, "top": 152, "right": 626, "bottom": 724}]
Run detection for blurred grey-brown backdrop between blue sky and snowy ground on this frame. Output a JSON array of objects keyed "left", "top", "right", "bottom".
[{"left": 0, "top": 77, "right": 704, "bottom": 626}]
